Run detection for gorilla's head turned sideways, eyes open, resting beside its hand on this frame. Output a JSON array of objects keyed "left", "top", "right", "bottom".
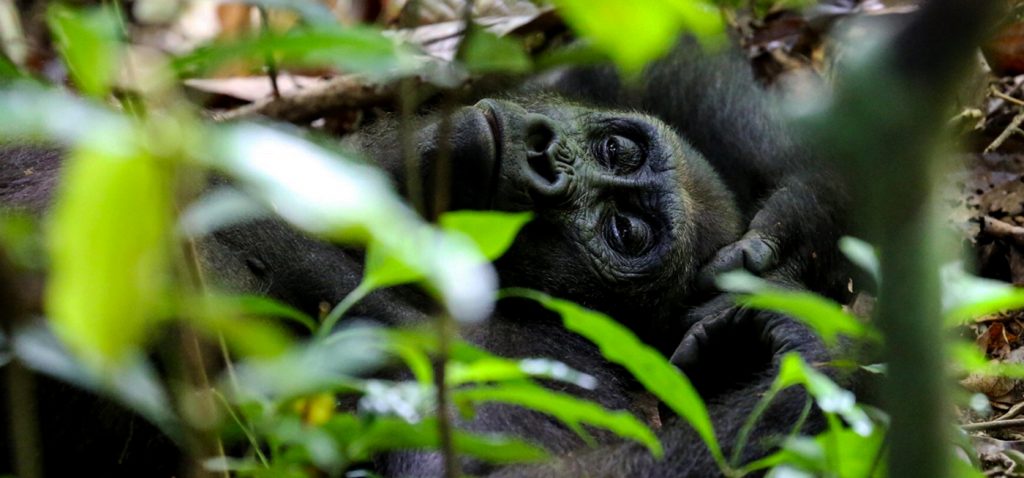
[{"left": 353, "top": 96, "right": 739, "bottom": 343}]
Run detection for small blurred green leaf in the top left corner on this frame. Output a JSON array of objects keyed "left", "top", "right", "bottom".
[{"left": 46, "top": 4, "right": 121, "bottom": 96}]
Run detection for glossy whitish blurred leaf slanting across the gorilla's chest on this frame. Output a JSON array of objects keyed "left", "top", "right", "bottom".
[{"left": 218, "top": 125, "right": 497, "bottom": 323}]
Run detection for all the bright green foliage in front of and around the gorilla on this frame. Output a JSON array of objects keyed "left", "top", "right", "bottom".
[{"left": 0, "top": 0, "right": 1007, "bottom": 477}]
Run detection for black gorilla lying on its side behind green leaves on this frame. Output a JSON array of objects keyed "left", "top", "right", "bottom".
[{"left": 0, "top": 35, "right": 846, "bottom": 476}]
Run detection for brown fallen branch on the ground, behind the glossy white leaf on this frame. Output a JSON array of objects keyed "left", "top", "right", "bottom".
[{"left": 212, "top": 76, "right": 432, "bottom": 122}]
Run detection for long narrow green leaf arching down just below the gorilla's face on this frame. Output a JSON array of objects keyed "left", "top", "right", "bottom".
[{"left": 503, "top": 289, "right": 726, "bottom": 468}]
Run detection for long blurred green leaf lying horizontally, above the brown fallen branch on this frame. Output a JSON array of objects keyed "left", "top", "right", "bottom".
[{"left": 173, "top": 27, "right": 422, "bottom": 78}]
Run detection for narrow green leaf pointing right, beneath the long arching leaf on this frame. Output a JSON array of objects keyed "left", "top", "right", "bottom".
[{"left": 452, "top": 383, "right": 664, "bottom": 458}]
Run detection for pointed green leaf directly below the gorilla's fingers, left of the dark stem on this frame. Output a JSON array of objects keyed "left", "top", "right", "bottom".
[{"left": 736, "top": 289, "right": 881, "bottom": 345}]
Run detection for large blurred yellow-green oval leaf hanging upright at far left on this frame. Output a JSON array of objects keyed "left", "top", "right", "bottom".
[{"left": 46, "top": 143, "right": 171, "bottom": 366}]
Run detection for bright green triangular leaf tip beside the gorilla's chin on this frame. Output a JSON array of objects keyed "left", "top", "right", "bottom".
[{"left": 438, "top": 211, "right": 534, "bottom": 261}]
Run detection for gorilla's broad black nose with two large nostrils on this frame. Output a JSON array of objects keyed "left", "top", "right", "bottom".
[{"left": 523, "top": 114, "right": 568, "bottom": 195}]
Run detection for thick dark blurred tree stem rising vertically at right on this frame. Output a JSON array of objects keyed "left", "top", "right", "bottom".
[{"left": 806, "top": 0, "right": 997, "bottom": 478}]
